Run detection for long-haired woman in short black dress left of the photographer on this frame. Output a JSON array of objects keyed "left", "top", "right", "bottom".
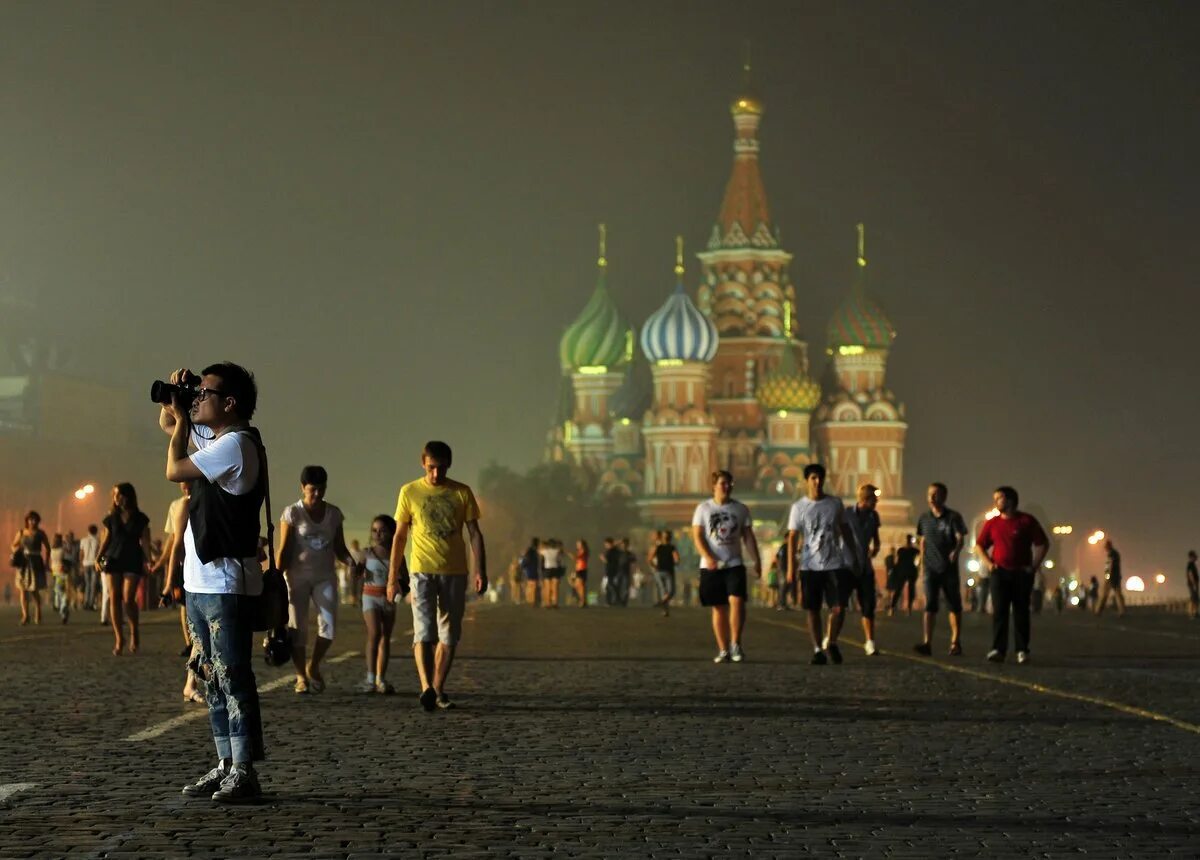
[{"left": 100, "top": 483, "right": 150, "bottom": 656}]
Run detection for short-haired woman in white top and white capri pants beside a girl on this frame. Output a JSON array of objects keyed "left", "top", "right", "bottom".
[{"left": 278, "top": 465, "right": 352, "bottom": 693}]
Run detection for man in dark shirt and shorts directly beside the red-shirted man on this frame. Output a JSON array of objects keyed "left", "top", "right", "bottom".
[{"left": 914, "top": 481, "right": 967, "bottom": 657}]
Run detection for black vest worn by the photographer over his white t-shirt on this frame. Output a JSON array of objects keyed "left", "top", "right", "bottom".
[{"left": 187, "top": 427, "right": 266, "bottom": 564}]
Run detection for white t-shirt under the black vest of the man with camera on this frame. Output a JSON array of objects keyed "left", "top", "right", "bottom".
[{"left": 184, "top": 428, "right": 263, "bottom": 595}]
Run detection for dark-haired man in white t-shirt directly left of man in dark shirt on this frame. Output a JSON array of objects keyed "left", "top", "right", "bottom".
[{"left": 787, "top": 463, "right": 863, "bottom": 666}]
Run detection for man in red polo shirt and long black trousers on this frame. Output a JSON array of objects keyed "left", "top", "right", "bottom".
[{"left": 976, "top": 487, "right": 1050, "bottom": 663}]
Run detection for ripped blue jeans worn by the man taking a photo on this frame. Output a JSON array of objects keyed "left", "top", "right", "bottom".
[{"left": 187, "top": 591, "right": 264, "bottom": 764}]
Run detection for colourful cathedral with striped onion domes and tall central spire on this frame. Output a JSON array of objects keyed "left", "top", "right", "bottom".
[{"left": 547, "top": 67, "right": 912, "bottom": 563}]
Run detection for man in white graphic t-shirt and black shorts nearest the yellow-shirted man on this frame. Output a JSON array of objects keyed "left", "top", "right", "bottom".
[{"left": 691, "top": 470, "right": 762, "bottom": 663}]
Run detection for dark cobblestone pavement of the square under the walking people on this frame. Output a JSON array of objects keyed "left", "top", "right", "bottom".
[{"left": 0, "top": 605, "right": 1200, "bottom": 858}]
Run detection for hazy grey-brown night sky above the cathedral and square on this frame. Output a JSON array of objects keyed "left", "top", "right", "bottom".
[{"left": 0, "top": 0, "right": 1200, "bottom": 577}]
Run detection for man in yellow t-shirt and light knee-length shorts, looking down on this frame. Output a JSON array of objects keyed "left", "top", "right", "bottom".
[{"left": 388, "top": 441, "right": 487, "bottom": 711}]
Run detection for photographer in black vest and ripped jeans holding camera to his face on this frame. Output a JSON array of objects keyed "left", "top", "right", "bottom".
[{"left": 159, "top": 362, "right": 266, "bottom": 804}]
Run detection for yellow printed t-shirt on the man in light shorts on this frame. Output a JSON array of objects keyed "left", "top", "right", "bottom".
[{"left": 396, "top": 477, "right": 479, "bottom": 575}]
